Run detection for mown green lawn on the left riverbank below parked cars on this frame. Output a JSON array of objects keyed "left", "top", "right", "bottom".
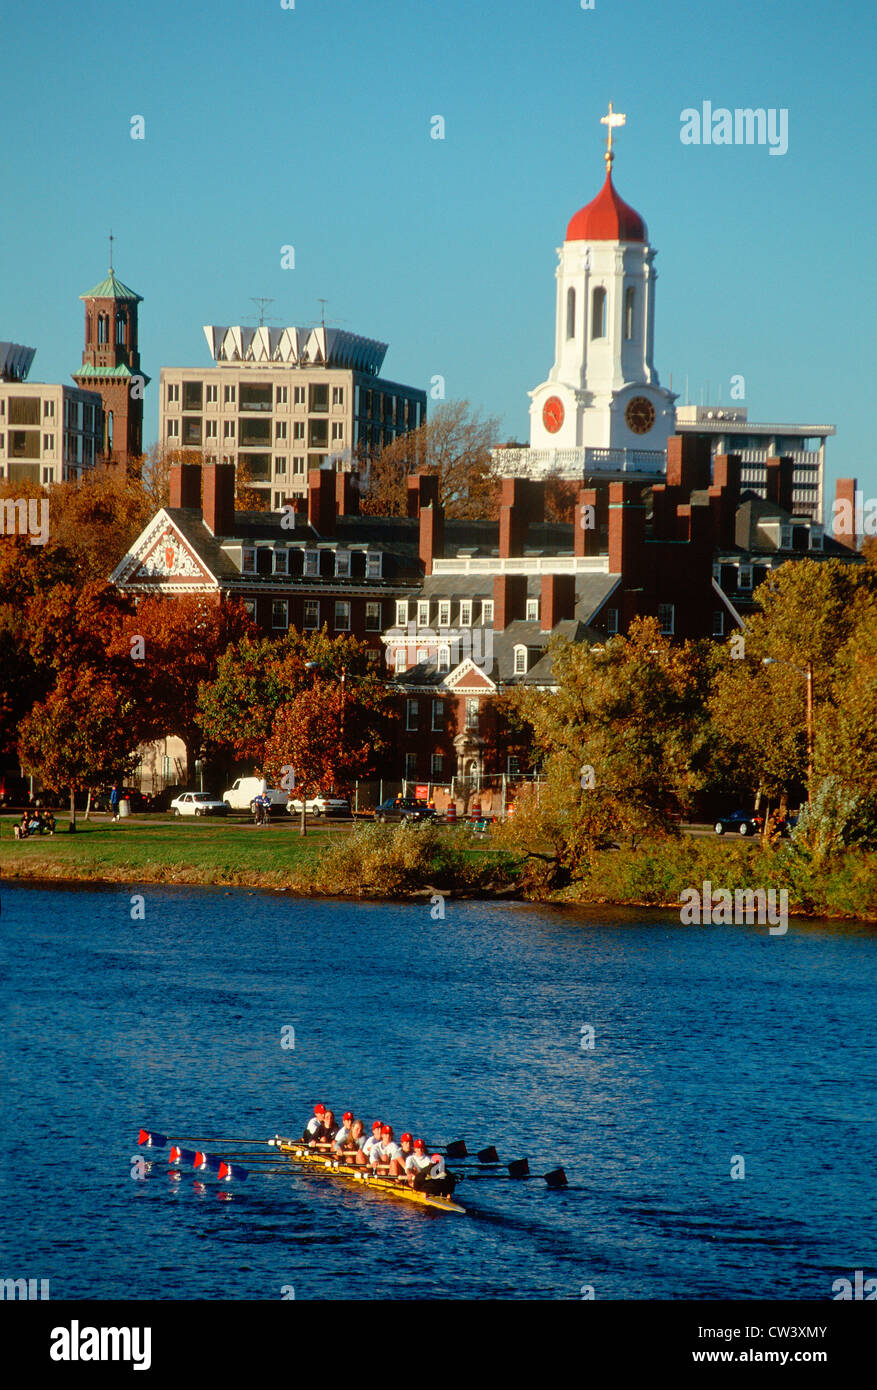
[{"left": 0, "top": 816, "right": 349, "bottom": 887}]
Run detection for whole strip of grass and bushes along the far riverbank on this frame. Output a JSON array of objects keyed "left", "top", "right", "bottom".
[{"left": 0, "top": 817, "right": 877, "bottom": 922}]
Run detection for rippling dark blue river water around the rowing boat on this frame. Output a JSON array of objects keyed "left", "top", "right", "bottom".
[{"left": 0, "top": 885, "right": 877, "bottom": 1300}]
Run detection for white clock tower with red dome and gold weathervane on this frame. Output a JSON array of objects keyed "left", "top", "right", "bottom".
[{"left": 530, "top": 103, "right": 675, "bottom": 452}]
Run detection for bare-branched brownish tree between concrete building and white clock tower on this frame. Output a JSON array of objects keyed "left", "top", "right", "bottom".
[{"left": 361, "top": 400, "right": 499, "bottom": 518}]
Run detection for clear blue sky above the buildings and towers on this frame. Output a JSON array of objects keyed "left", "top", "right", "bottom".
[{"left": 0, "top": 0, "right": 877, "bottom": 496}]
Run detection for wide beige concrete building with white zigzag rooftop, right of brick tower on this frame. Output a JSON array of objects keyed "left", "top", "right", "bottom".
[{"left": 160, "top": 324, "right": 427, "bottom": 510}]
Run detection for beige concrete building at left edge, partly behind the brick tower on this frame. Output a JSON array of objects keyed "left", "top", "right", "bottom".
[{"left": 0, "top": 343, "right": 104, "bottom": 485}]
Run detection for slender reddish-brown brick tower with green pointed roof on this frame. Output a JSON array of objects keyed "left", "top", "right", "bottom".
[{"left": 72, "top": 238, "right": 149, "bottom": 467}]
